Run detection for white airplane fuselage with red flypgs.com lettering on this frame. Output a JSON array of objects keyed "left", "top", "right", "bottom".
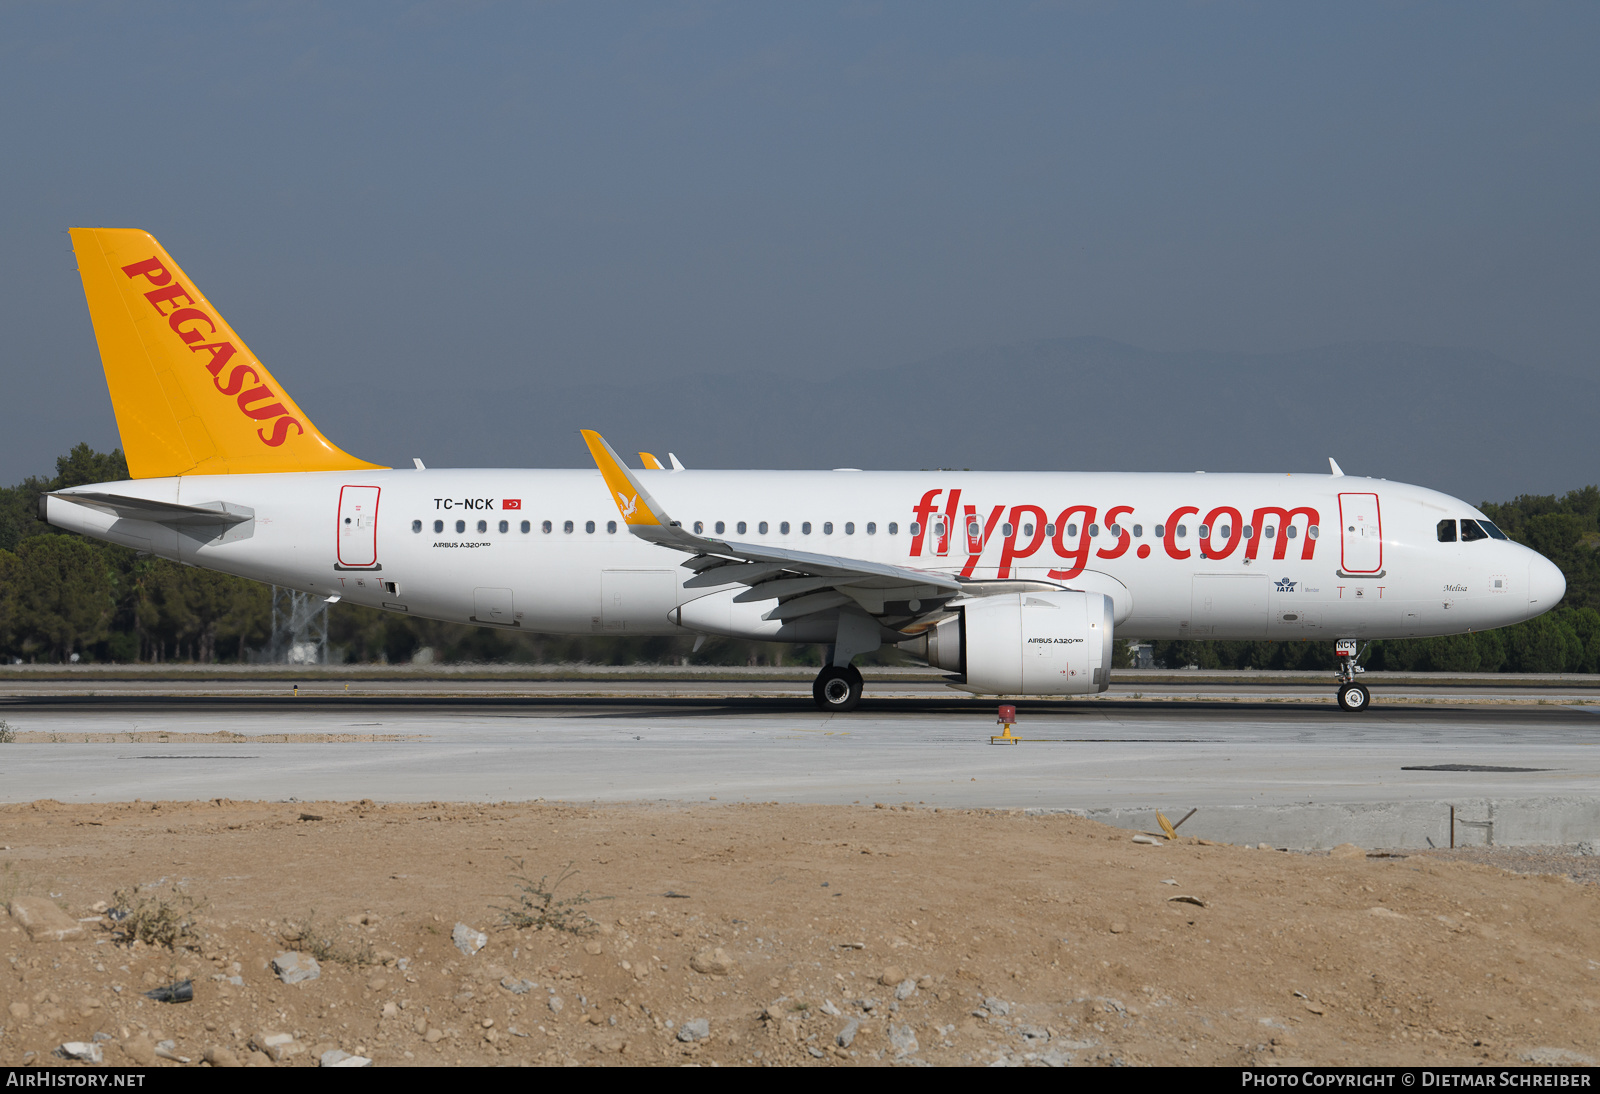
[{"left": 48, "top": 469, "right": 1565, "bottom": 641}]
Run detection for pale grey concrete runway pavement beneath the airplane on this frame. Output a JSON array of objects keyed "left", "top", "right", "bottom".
[{"left": 0, "top": 681, "right": 1600, "bottom": 846}]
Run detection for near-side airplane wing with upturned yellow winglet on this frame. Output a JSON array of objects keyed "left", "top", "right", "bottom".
[{"left": 582, "top": 429, "right": 968, "bottom": 630}]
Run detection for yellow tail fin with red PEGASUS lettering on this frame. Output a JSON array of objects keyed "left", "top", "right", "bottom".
[{"left": 72, "top": 229, "right": 379, "bottom": 478}]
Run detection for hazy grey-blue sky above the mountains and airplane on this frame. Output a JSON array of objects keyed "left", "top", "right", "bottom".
[{"left": 0, "top": 2, "right": 1600, "bottom": 486}]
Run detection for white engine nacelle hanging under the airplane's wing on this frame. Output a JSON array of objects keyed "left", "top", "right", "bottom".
[{"left": 901, "top": 590, "right": 1115, "bottom": 696}]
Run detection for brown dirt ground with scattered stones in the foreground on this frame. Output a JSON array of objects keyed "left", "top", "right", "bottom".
[{"left": 0, "top": 801, "right": 1600, "bottom": 1067}]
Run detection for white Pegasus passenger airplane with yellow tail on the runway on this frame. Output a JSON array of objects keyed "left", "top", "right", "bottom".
[{"left": 38, "top": 229, "right": 1566, "bottom": 712}]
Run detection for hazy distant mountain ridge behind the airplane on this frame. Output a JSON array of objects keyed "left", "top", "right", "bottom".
[{"left": 308, "top": 337, "right": 1600, "bottom": 502}]
